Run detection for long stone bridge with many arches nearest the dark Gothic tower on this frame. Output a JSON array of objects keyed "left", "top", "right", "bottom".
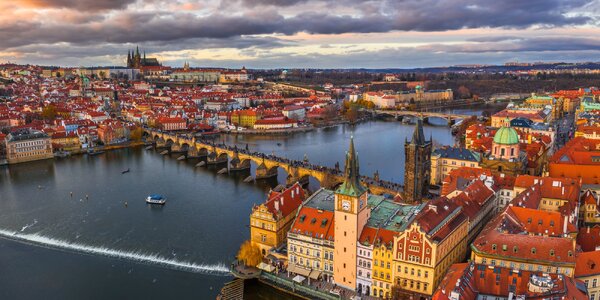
[{"left": 144, "top": 129, "right": 402, "bottom": 196}]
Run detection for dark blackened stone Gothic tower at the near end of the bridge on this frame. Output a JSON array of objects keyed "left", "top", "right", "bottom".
[{"left": 404, "top": 118, "right": 432, "bottom": 203}]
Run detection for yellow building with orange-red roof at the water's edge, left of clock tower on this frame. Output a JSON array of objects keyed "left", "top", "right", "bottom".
[{"left": 250, "top": 183, "right": 305, "bottom": 256}]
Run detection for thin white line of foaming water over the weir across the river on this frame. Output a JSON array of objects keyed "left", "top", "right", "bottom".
[{"left": 0, "top": 229, "right": 229, "bottom": 276}]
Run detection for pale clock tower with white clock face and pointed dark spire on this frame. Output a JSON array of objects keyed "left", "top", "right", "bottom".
[{"left": 333, "top": 138, "right": 370, "bottom": 290}]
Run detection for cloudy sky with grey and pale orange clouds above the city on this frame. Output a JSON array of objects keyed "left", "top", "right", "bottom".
[{"left": 0, "top": 0, "right": 600, "bottom": 68}]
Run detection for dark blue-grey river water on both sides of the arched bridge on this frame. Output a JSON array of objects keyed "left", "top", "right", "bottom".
[{"left": 0, "top": 103, "right": 506, "bottom": 299}]
